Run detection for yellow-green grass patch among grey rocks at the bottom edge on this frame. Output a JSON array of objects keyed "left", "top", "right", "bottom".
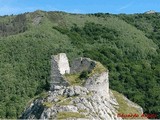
[{"left": 57, "top": 112, "right": 85, "bottom": 119}]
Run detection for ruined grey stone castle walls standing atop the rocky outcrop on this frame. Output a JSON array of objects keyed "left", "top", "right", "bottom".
[{"left": 51, "top": 53, "right": 109, "bottom": 98}]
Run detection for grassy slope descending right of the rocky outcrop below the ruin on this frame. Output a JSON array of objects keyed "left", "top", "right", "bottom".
[{"left": 112, "top": 90, "right": 142, "bottom": 115}]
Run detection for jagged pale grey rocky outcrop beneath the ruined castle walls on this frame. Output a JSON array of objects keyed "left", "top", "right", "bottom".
[{"left": 21, "top": 86, "right": 121, "bottom": 120}]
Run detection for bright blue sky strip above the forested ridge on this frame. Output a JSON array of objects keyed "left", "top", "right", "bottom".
[{"left": 0, "top": 0, "right": 160, "bottom": 15}]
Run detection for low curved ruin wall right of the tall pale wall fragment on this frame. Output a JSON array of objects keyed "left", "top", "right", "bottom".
[{"left": 71, "top": 57, "right": 109, "bottom": 99}]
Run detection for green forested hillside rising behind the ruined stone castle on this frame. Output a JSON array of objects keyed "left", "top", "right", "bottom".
[{"left": 0, "top": 11, "right": 160, "bottom": 118}]
